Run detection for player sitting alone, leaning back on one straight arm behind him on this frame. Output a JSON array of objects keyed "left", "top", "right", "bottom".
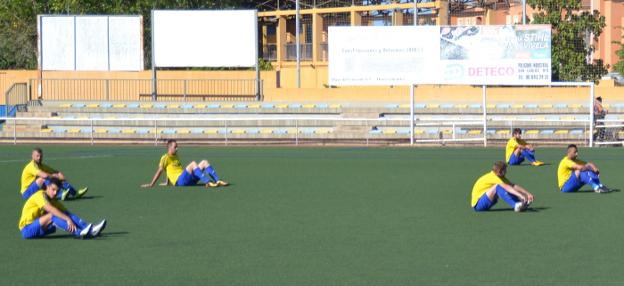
[{"left": 141, "top": 140, "right": 229, "bottom": 188}]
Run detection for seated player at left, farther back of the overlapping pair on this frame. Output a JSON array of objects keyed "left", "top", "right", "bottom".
[{"left": 20, "top": 148, "right": 88, "bottom": 201}]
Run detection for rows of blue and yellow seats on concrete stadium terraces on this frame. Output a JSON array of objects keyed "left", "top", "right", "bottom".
[{"left": 2, "top": 99, "right": 624, "bottom": 144}]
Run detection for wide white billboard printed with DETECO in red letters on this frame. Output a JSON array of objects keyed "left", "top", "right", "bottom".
[{"left": 329, "top": 25, "right": 551, "bottom": 85}]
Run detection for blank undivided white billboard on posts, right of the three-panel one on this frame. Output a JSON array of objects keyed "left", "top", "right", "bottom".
[{"left": 152, "top": 10, "right": 258, "bottom": 67}]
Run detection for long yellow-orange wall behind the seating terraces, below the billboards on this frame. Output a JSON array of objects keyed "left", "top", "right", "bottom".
[{"left": 0, "top": 68, "right": 624, "bottom": 104}]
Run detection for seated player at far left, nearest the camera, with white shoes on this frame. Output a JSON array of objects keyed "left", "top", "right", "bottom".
[{"left": 19, "top": 177, "right": 106, "bottom": 239}]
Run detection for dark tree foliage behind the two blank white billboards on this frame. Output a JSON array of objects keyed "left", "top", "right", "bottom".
[{"left": 0, "top": 0, "right": 256, "bottom": 69}]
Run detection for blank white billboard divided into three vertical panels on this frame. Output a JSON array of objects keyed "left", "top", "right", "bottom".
[{"left": 38, "top": 15, "right": 143, "bottom": 71}]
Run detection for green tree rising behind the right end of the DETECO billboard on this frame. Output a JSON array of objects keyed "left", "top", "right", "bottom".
[{"left": 527, "top": 0, "right": 608, "bottom": 81}]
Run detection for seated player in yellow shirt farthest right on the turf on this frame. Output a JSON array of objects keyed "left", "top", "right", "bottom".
[{"left": 557, "top": 144, "right": 611, "bottom": 193}]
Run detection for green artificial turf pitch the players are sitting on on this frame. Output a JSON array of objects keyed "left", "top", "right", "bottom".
[{"left": 0, "top": 145, "right": 624, "bottom": 285}]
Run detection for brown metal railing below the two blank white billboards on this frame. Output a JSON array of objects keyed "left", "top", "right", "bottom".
[{"left": 29, "top": 79, "right": 262, "bottom": 101}]
